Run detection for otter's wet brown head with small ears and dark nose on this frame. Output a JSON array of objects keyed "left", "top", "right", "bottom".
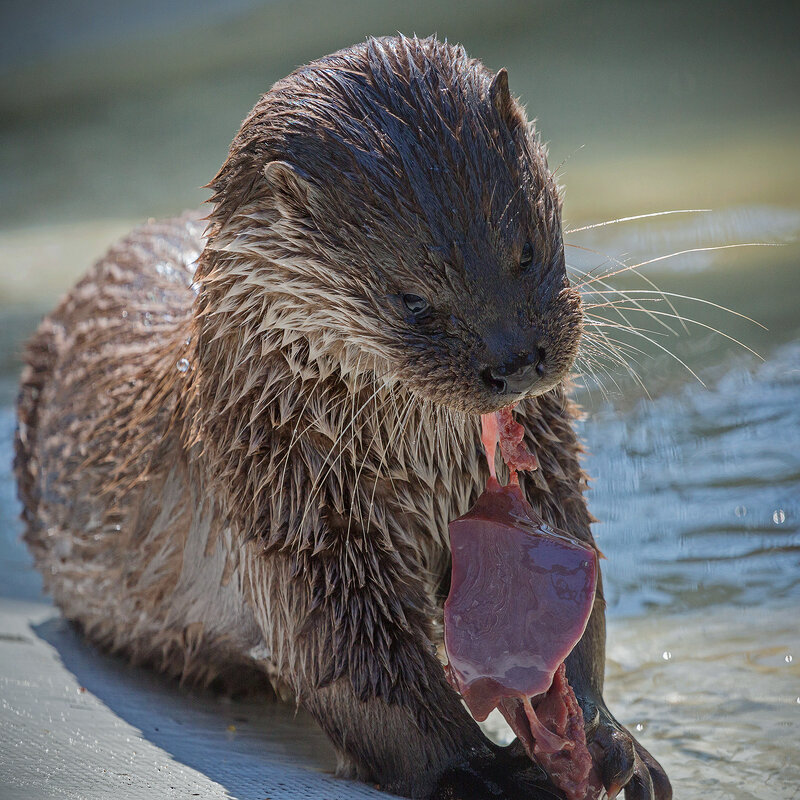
[{"left": 209, "top": 37, "right": 581, "bottom": 413}]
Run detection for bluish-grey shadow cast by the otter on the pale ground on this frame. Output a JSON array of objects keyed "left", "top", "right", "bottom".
[{"left": 31, "top": 617, "right": 387, "bottom": 800}]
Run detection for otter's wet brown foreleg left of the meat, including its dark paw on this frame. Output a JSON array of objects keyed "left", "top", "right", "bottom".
[{"left": 265, "top": 532, "right": 557, "bottom": 800}]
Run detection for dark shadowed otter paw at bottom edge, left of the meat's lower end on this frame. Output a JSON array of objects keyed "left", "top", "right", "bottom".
[{"left": 431, "top": 745, "right": 563, "bottom": 800}]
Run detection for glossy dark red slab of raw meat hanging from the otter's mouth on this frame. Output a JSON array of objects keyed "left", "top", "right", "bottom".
[{"left": 444, "top": 408, "right": 602, "bottom": 800}]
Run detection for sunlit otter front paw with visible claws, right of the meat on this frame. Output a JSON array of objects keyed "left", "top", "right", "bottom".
[{"left": 583, "top": 703, "right": 672, "bottom": 800}]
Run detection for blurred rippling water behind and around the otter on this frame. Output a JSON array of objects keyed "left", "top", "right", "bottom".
[{"left": 0, "top": 0, "right": 800, "bottom": 800}]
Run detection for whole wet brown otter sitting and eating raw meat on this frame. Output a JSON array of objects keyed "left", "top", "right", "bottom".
[{"left": 15, "top": 36, "right": 671, "bottom": 800}]
